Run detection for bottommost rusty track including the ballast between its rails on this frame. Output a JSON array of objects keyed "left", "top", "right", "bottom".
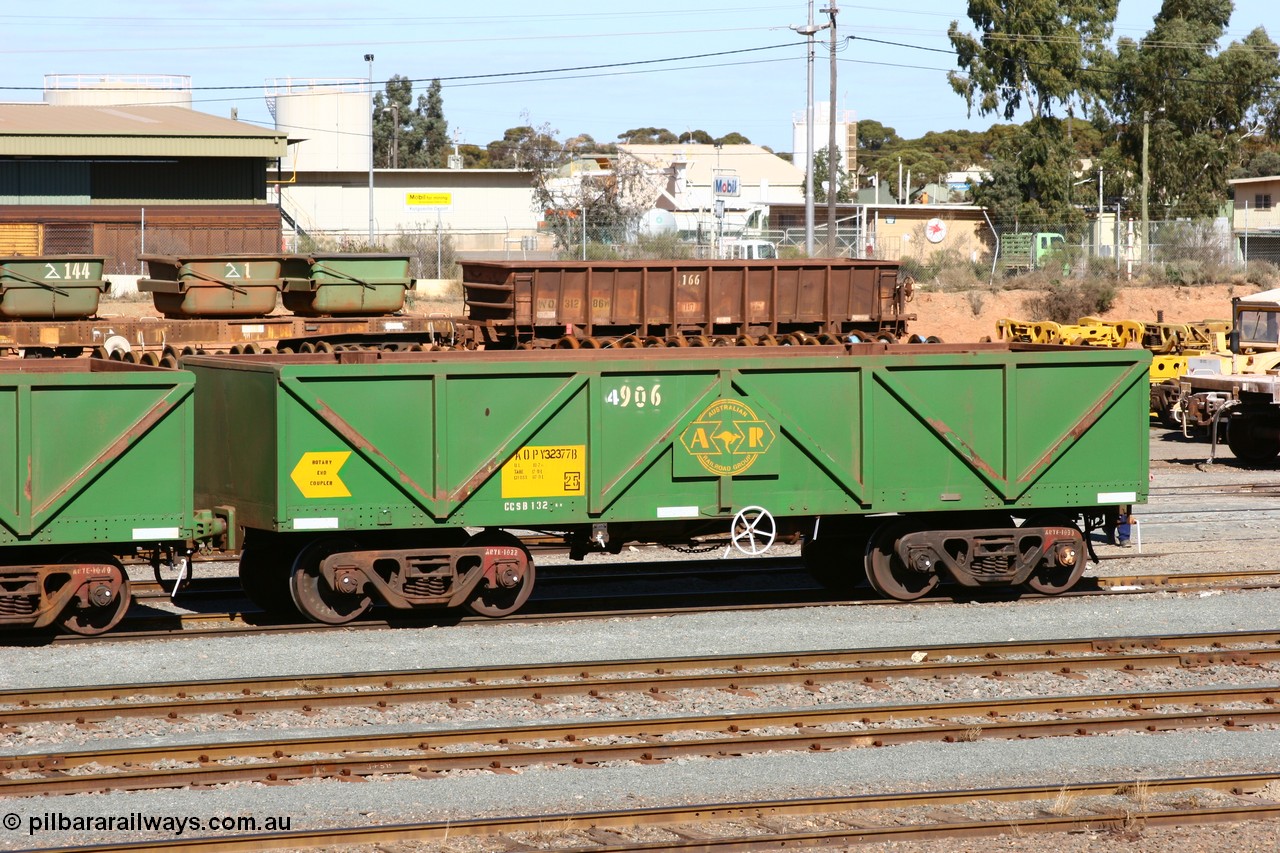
[{"left": 20, "top": 774, "right": 1280, "bottom": 853}]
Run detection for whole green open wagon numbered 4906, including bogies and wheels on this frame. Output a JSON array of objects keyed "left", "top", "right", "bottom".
[{"left": 184, "top": 345, "right": 1151, "bottom": 622}]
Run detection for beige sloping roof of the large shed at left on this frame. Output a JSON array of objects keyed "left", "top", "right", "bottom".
[{"left": 0, "top": 104, "right": 288, "bottom": 158}]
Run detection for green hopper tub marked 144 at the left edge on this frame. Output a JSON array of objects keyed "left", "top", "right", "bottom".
[{"left": 0, "top": 255, "right": 110, "bottom": 320}]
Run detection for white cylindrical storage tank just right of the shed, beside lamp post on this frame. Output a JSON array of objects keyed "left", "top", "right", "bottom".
[{"left": 266, "top": 77, "right": 374, "bottom": 172}]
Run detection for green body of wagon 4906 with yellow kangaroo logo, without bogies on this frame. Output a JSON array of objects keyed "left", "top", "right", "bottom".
[{"left": 186, "top": 345, "right": 1149, "bottom": 532}]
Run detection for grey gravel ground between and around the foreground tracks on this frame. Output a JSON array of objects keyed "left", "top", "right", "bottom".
[{"left": 0, "top": 432, "right": 1280, "bottom": 852}]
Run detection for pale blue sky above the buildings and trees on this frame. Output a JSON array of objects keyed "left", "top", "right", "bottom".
[{"left": 0, "top": 0, "right": 1280, "bottom": 151}]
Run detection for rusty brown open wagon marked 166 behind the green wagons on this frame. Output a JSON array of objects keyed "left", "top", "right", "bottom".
[{"left": 461, "top": 259, "right": 914, "bottom": 347}]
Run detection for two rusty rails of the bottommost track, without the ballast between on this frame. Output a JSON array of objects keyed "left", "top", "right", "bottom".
[{"left": 22, "top": 774, "right": 1280, "bottom": 853}]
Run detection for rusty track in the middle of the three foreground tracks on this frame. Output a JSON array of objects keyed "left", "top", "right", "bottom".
[{"left": 0, "top": 685, "right": 1280, "bottom": 797}]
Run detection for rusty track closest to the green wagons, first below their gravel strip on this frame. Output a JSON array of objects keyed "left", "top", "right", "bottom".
[{"left": 0, "top": 631, "right": 1280, "bottom": 722}]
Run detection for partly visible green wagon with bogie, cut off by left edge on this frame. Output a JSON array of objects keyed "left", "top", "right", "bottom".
[{"left": 0, "top": 359, "right": 227, "bottom": 634}]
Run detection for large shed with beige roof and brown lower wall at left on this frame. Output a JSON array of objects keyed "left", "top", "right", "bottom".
[{"left": 0, "top": 85, "right": 288, "bottom": 274}]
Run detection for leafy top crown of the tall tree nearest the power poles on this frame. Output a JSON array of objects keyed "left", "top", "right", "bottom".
[{"left": 947, "top": 0, "right": 1117, "bottom": 120}]
